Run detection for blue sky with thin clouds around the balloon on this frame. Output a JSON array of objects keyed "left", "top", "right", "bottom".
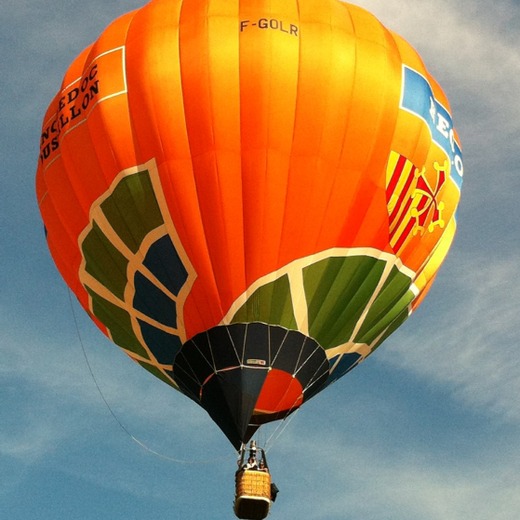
[{"left": 0, "top": 0, "right": 520, "bottom": 520}]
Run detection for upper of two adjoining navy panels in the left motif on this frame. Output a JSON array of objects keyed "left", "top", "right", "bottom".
[{"left": 143, "top": 235, "right": 188, "bottom": 296}]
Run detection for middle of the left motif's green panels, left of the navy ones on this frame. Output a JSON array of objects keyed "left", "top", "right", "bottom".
[{"left": 81, "top": 222, "right": 128, "bottom": 300}]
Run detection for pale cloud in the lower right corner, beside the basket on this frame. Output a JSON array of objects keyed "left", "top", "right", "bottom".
[{"left": 272, "top": 408, "right": 520, "bottom": 520}]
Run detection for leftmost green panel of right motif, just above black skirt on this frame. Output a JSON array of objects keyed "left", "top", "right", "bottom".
[{"left": 232, "top": 275, "right": 298, "bottom": 330}]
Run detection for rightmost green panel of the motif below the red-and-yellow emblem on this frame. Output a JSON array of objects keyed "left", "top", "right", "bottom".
[{"left": 356, "top": 267, "right": 414, "bottom": 343}]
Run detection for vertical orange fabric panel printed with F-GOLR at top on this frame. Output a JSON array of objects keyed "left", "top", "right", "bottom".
[{"left": 238, "top": 0, "right": 301, "bottom": 285}]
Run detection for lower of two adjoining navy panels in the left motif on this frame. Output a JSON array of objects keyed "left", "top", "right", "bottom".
[{"left": 133, "top": 272, "right": 177, "bottom": 327}]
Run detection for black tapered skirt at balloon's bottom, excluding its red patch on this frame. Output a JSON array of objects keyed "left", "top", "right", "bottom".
[{"left": 173, "top": 323, "right": 329, "bottom": 449}]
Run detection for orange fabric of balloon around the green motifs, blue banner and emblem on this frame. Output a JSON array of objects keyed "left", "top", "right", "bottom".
[{"left": 36, "top": 0, "right": 460, "bottom": 346}]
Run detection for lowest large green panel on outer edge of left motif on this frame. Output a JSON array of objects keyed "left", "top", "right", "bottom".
[{"left": 87, "top": 288, "right": 149, "bottom": 359}]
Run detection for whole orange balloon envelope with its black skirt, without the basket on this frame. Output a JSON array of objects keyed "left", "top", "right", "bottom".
[{"left": 36, "top": 0, "right": 463, "bottom": 516}]
